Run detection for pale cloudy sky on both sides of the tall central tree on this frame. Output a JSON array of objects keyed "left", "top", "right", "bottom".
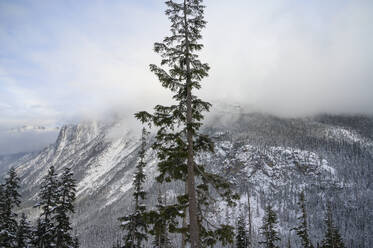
[{"left": 0, "top": 0, "right": 373, "bottom": 153}]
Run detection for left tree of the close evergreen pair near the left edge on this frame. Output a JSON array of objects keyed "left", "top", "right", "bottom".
[{"left": 35, "top": 166, "right": 58, "bottom": 248}]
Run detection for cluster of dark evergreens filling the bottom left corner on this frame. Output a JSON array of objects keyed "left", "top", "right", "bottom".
[{"left": 0, "top": 166, "right": 79, "bottom": 248}]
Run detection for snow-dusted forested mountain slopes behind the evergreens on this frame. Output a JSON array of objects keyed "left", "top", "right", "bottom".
[{"left": 5, "top": 111, "right": 373, "bottom": 248}]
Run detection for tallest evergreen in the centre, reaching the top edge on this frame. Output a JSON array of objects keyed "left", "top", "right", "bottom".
[{"left": 136, "top": 0, "right": 236, "bottom": 248}]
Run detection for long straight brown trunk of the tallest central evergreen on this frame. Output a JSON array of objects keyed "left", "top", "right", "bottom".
[{"left": 184, "top": 0, "right": 200, "bottom": 248}]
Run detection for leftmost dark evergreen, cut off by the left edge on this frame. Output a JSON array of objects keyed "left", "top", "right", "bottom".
[{"left": 0, "top": 168, "right": 20, "bottom": 248}]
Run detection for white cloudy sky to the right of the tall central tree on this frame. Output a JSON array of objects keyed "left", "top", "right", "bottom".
[{"left": 204, "top": 1, "right": 373, "bottom": 116}]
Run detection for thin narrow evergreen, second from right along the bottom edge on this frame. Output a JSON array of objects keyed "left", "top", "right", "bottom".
[{"left": 294, "top": 191, "right": 313, "bottom": 248}]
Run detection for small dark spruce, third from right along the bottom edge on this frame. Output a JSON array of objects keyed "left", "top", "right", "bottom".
[{"left": 259, "top": 204, "right": 281, "bottom": 248}]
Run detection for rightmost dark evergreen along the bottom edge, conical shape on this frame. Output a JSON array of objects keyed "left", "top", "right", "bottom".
[{"left": 321, "top": 203, "right": 345, "bottom": 248}]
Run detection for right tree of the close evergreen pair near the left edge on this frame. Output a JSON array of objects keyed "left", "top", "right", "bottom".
[{"left": 53, "top": 167, "right": 76, "bottom": 248}]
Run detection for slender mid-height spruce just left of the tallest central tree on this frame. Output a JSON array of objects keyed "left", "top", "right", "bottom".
[{"left": 119, "top": 128, "right": 148, "bottom": 248}]
